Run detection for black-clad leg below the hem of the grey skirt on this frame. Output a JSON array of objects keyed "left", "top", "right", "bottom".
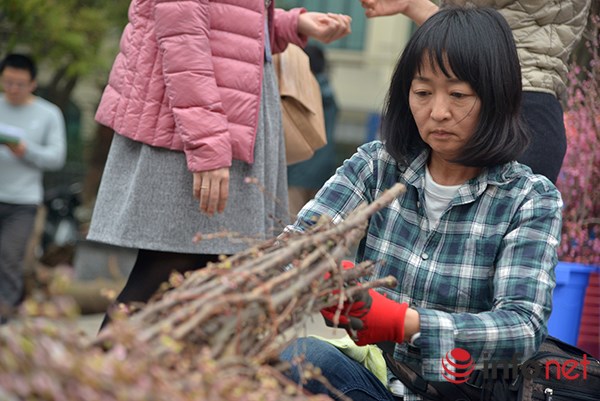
[{"left": 100, "top": 249, "right": 219, "bottom": 330}]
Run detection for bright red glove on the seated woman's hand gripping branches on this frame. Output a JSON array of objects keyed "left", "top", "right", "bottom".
[{"left": 321, "top": 289, "right": 408, "bottom": 345}]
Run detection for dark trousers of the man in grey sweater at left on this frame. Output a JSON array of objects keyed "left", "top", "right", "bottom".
[{"left": 0, "top": 203, "right": 37, "bottom": 315}]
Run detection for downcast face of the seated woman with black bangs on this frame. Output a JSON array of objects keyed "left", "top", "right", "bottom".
[{"left": 408, "top": 56, "right": 481, "bottom": 160}]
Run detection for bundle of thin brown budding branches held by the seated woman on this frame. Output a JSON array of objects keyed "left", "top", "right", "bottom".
[{"left": 0, "top": 184, "right": 404, "bottom": 401}]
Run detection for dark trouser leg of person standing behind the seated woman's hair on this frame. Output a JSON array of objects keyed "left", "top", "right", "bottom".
[{"left": 517, "top": 91, "right": 567, "bottom": 183}]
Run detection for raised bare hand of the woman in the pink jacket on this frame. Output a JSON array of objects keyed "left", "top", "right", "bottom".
[{"left": 298, "top": 12, "right": 352, "bottom": 43}]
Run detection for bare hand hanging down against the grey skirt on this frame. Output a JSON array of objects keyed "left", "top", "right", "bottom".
[{"left": 193, "top": 167, "right": 229, "bottom": 216}]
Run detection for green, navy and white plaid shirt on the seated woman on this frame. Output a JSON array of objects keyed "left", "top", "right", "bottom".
[{"left": 288, "top": 141, "right": 562, "bottom": 388}]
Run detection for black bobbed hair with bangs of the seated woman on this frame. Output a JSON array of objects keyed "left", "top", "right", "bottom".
[{"left": 381, "top": 6, "right": 529, "bottom": 167}]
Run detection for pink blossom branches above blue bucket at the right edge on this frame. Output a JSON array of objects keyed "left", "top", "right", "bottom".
[{"left": 557, "top": 17, "right": 600, "bottom": 266}]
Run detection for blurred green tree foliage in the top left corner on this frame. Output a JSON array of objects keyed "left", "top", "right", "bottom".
[{"left": 0, "top": 0, "right": 129, "bottom": 110}]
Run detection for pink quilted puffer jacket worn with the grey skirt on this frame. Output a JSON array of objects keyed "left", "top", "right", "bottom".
[{"left": 96, "top": 0, "right": 306, "bottom": 171}]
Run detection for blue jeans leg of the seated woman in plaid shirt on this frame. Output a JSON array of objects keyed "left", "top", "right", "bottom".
[{"left": 280, "top": 337, "right": 396, "bottom": 401}]
